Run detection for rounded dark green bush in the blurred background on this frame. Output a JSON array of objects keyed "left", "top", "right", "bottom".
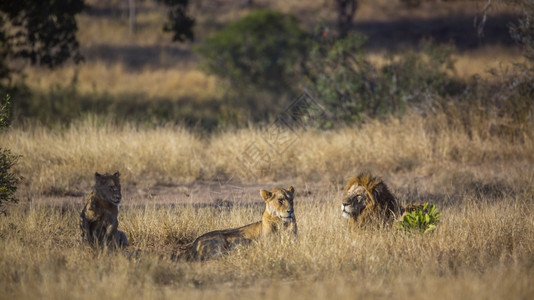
[{"left": 196, "top": 10, "right": 307, "bottom": 94}]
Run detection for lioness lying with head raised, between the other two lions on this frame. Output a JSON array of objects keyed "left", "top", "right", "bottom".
[{"left": 180, "top": 186, "right": 297, "bottom": 260}]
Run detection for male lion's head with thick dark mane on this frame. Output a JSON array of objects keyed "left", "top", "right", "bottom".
[{"left": 341, "top": 174, "right": 399, "bottom": 225}]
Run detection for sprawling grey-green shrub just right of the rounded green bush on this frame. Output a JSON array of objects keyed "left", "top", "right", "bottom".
[{"left": 306, "top": 34, "right": 464, "bottom": 127}]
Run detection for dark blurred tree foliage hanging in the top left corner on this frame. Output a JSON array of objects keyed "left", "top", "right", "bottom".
[{"left": 0, "top": 0, "right": 85, "bottom": 86}]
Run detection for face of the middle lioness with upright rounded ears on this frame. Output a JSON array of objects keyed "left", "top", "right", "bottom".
[{"left": 260, "top": 186, "right": 295, "bottom": 222}]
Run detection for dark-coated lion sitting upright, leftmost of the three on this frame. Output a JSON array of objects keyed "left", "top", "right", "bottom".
[{"left": 80, "top": 172, "right": 128, "bottom": 248}]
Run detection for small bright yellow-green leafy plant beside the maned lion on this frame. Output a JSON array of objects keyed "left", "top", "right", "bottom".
[{"left": 397, "top": 203, "right": 441, "bottom": 233}]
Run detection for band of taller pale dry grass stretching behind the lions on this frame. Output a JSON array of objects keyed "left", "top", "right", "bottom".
[{"left": 0, "top": 109, "right": 534, "bottom": 194}]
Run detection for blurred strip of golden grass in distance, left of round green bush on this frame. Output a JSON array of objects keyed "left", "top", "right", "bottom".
[{"left": 26, "top": 61, "right": 220, "bottom": 101}]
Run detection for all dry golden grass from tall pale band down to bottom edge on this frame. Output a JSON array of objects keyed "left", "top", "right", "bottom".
[{"left": 0, "top": 108, "right": 534, "bottom": 299}]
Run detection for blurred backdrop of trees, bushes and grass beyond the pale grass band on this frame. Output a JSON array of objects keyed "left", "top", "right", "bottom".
[{"left": 0, "top": 0, "right": 534, "bottom": 131}]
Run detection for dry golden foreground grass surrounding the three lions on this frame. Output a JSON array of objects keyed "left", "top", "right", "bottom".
[{"left": 0, "top": 187, "right": 534, "bottom": 299}]
